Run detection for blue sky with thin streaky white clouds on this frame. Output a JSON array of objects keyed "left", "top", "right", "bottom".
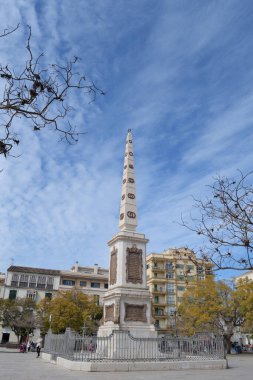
[{"left": 0, "top": 0, "right": 253, "bottom": 277}]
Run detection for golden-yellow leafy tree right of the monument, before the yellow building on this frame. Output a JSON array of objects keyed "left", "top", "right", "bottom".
[{"left": 179, "top": 278, "right": 253, "bottom": 352}]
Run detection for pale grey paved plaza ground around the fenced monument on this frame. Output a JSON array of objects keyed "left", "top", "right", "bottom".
[{"left": 0, "top": 349, "right": 253, "bottom": 380}]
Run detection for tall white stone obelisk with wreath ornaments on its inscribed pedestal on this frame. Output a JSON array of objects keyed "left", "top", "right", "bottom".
[{"left": 98, "top": 130, "right": 157, "bottom": 337}]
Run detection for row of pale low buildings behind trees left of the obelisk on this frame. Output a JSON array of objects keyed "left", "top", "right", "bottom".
[{"left": 0, "top": 262, "right": 108, "bottom": 343}]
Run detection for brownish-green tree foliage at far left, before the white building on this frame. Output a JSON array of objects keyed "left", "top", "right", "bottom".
[{"left": 0, "top": 298, "right": 37, "bottom": 341}]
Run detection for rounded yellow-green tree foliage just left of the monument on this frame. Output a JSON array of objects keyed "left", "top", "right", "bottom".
[{"left": 38, "top": 289, "right": 102, "bottom": 333}]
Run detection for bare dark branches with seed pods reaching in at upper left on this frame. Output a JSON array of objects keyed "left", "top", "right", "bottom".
[{"left": 0, "top": 25, "right": 104, "bottom": 157}]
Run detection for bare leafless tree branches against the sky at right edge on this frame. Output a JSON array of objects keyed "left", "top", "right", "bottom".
[{"left": 182, "top": 171, "right": 253, "bottom": 270}]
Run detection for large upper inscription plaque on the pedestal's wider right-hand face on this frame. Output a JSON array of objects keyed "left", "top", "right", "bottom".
[{"left": 126, "top": 247, "right": 142, "bottom": 284}]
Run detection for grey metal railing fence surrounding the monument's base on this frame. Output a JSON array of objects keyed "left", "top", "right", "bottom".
[{"left": 44, "top": 329, "right": 225, "bottom": 361}]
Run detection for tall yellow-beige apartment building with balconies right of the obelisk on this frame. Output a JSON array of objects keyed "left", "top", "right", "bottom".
[{"left": 146, "top": 248, "right": 211, "bottom": 334}]
